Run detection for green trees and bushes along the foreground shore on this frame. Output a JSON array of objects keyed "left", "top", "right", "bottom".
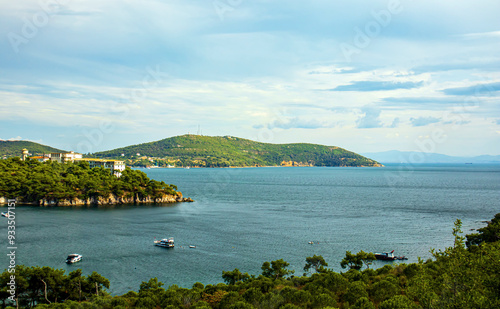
[{"left": 0, "top": 213, "right": 500, "bottom": 309}]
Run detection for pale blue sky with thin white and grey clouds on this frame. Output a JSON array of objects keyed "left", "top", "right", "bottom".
[{"left": 0, "top": 0, "right": 500, "bottom": 156}]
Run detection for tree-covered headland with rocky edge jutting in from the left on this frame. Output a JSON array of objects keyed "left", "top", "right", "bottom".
[{"left": 0, "top": 157, "right": 193, "bottom": 206}]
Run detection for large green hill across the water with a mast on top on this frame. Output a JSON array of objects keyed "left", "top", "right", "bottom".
[{"left": 91, "top": 135, "right": 380, "bottom": 167}]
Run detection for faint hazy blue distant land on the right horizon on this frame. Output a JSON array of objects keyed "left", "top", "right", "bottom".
[{"left": 362, "top": 150, "right": 500, "bottom": 164}]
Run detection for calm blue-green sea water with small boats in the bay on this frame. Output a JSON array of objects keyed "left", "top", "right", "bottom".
[{"left": 0, "top": 165, "right": 500, "bottom": 294}]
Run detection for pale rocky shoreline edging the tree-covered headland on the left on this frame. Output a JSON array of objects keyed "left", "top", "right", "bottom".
[{"left": 0, "top": 192, "right": 194, "bottom": 206}]
